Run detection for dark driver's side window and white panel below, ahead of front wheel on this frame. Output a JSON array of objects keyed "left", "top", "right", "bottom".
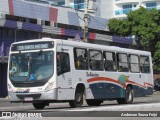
[{"left": 57, "top": 52, "right": 73, "bottom": 100}]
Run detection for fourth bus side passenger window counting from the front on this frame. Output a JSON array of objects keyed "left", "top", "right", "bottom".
[{"left": 117, "top": 53, "right": 128, "bottom": 72}]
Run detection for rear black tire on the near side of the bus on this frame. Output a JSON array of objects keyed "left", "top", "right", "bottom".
[{"left": 117, "top": 87, "right": 134, "bottom": 104}]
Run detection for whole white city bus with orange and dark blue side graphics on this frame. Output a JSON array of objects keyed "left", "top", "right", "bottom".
[{"left": 8, "top": 38, "right": 153, "bottom": 109}]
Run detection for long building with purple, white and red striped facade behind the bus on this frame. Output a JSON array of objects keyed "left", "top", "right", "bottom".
[{"left": 0, "top": 0, "right": 133, "bottom": 97}]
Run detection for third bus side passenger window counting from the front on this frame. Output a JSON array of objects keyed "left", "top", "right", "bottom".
[{"left": 103, "top": 52, "right": 116, "bottom": 71}]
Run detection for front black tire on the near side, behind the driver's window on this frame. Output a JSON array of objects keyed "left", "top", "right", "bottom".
[{"left": 69, "top": 89, "right": 84, "bottom": 108}]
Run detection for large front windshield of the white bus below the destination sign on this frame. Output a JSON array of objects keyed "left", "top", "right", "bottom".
[{"left": 9, "top": 51, "right": 54, "bottom": 82}]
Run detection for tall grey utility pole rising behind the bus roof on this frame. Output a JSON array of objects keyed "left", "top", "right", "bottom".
[{"left": 83, "top": 0, "right": 89, "bottom": 42}]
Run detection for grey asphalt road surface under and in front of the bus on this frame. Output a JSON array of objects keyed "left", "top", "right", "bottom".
[{"left": 0, "top": 92, "right": 160, "bottom": 120}]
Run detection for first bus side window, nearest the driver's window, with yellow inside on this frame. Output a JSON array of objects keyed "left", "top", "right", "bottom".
[{"left": 74, "top": 48, "right": 88, "bottom": 70}]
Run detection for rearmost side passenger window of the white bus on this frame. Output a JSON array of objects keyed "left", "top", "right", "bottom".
[{"left": 140, "top": 56, "right": 150, "bottom": 73}]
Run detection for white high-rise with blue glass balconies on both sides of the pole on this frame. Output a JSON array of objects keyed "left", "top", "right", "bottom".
[{"left": 24, "top": 0, "right": 160, "bottom": 19}]
